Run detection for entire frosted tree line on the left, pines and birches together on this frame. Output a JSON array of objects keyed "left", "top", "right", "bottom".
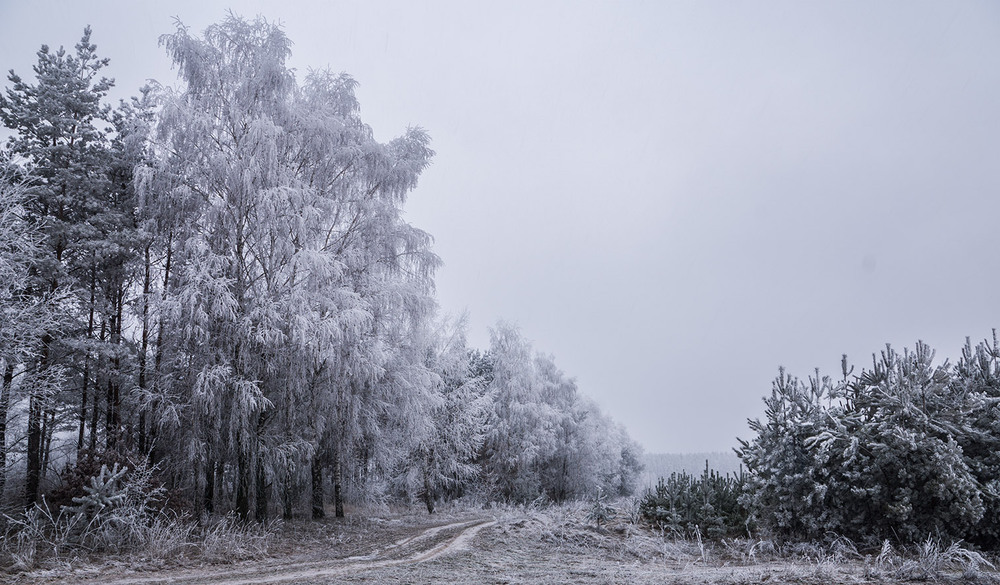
[{"left": 0, "top": 15, "right": 640, "bottom": 521}]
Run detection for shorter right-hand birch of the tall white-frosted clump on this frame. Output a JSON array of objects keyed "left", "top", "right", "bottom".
[{"left": 280, "top": 72, "right": 439, "bottom": 515}]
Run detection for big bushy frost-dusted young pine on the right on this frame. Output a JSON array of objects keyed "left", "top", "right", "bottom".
[{"left": 740, "top": 342, "right": 993, "bottom": 543}]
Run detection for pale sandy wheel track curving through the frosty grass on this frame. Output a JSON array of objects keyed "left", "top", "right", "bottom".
[{"left": 68, "top": 519, "right": 496, "bottom": 585}]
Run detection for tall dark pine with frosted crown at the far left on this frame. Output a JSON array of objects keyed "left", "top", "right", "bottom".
[{"left": 0, "top": 27, "right": 128, "bottom": 505}]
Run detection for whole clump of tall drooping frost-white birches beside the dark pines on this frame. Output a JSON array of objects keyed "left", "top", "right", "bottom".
[{"left": 140, "top": 16, "right": 437, "bottom": 518}]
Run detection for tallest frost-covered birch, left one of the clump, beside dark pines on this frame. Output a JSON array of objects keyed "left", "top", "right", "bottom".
[{"left": 140, "top": 18, "right": 295, "bottom": 518}]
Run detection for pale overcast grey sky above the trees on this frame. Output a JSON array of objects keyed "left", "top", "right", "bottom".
[{"left": 0, "top": 0, "right": 1000, "bottom": 452}]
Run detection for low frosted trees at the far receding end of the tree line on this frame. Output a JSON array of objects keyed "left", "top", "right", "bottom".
[{"left": 470, "top": 323, "right": 642, "bottom": 501}]
